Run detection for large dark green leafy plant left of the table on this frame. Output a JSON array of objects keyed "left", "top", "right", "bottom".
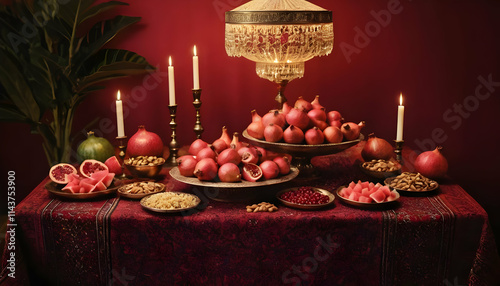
[{"left": 0, "top": 0, "right": 154, "bottom": 165}]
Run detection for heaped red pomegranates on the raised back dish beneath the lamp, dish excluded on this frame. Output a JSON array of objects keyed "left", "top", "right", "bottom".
[{"left": 246, "top": 95, "right": 365, "bottom": 145}]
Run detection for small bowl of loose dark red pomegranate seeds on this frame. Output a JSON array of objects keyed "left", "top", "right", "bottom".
[{"left": 276, "top": 186, "right": 335, "bottom": 210}]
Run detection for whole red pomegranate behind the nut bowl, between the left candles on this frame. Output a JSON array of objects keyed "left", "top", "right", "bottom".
[{"left": 127, "top": 125, "right": 163, "bottom": 157}]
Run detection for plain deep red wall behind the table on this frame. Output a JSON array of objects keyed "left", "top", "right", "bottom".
[{"left": 0, "top": 0, "right": 500, "bottom": 244}]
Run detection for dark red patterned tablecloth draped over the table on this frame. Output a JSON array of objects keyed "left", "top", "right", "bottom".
[{"left": 0, "top": 145, "right": 500, "bottom": 285}]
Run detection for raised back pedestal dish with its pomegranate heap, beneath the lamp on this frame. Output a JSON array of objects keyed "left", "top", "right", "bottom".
[{"left": 242, "top": 95, "right": 365, "bottom": 176}]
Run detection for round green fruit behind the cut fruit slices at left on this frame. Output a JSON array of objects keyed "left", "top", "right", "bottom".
[{"left": 76, "top": 131, "right": 115, "bottom": 162}]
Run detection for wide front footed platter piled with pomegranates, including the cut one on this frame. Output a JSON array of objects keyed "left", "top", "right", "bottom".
[{"left": 170, "top": 134, "right": 299, "bottom": 201}]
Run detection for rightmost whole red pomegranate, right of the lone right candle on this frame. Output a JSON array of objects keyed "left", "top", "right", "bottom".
[{"left": 415, "top": 147, "right": 448, "bottom": 179}]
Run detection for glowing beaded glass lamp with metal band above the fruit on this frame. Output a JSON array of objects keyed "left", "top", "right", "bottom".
[{"left": 225, "top": 0, "right": 333, "bottom": 105}]
